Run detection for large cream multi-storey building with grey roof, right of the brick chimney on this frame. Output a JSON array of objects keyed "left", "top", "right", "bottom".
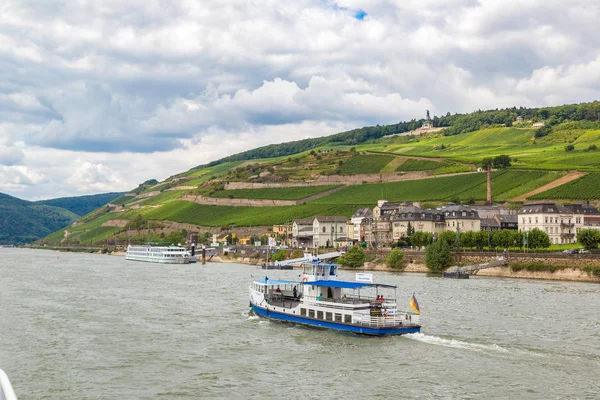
[{"left": 518, "top": 203, "right": 584, "bottom": 244}]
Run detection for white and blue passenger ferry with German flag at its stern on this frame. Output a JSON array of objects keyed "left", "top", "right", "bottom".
[{"left": 250, "top": 262, "right": 421, "bottom": 336}]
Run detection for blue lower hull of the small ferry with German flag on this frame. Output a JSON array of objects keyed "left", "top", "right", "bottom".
[{"left": 250, "top": 303, "right": 421, "bottom": 336}]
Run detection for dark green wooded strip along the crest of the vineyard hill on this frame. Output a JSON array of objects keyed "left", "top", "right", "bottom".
[{"left": 193, "top": 101, "right": 600, "bottom": 169}]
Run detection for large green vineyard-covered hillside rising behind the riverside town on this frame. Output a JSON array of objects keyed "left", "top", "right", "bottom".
[{"left": 45, "top": 102, "right": 600, "bottom": 244}]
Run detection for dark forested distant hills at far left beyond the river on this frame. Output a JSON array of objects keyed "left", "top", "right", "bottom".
[{"left": 0, "top": 193, "right": 121, "bottom": 244}]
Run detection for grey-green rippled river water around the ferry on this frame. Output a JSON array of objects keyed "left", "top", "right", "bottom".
[{"left": 0, "top": 249, "right": 600, "bottom": 399}]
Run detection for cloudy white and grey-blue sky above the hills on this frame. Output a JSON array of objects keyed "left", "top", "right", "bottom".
[{"left": 0, "top": 0, "right": 600, "bottom": 200}]
